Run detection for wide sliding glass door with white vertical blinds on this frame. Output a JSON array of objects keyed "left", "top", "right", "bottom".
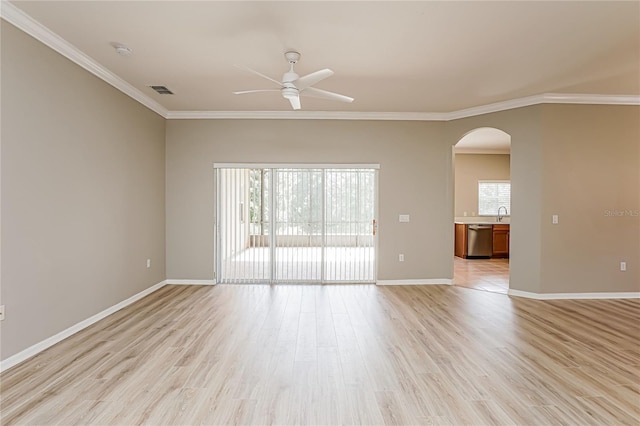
[{"left": 214, "top": 165, "right": 377, "bottom": 284}]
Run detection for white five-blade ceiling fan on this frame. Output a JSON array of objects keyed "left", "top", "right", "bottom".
[{"left": 233, "top": 51, "right": 353, "bottom": 110}]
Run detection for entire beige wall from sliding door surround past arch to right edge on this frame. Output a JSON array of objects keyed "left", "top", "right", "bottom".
[{"left": 167, "top": 105, "right": 640, "bottom": 293}]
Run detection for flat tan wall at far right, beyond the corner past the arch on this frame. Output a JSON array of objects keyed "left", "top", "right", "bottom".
[{"left": 541, "top": 105, "right": 640, "bottom": 293}]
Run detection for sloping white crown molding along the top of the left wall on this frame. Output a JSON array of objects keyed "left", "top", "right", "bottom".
[{"left": 0, "top": 0, "right": 167, "bottom": 118}]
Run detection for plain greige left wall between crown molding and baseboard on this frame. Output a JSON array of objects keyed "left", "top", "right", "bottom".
[{"left": 0, "top": 21, "right": 165, "bottom": 359}]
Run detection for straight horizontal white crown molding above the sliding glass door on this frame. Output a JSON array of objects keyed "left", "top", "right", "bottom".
[{"left": 166, "top": 110, "right": 447, "bottom": 121}]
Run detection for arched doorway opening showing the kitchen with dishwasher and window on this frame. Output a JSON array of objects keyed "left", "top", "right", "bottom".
[{"left": 453, "top": 127, "right": 511, "bottom": 294}]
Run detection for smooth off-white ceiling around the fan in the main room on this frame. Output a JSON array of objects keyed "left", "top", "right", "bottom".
[{"left": 6, "top": 1, "right": 640, "bottom": 113}]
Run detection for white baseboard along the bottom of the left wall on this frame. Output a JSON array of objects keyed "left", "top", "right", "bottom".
[{"left": 0, "top": 281, "right": 167, "bottom": 372}]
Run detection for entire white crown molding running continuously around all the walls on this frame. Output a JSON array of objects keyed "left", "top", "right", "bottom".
[{"left": 5, "top": 0, "right": 640, "bottom": 121}]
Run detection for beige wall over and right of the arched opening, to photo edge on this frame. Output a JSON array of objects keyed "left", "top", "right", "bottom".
[{"left": 448, "top": 105, "right": 640, "bottom": 293}]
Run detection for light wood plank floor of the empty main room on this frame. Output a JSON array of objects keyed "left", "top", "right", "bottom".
[{"left": 0, "top": 285, "right": 640, "bottom": 425}]
